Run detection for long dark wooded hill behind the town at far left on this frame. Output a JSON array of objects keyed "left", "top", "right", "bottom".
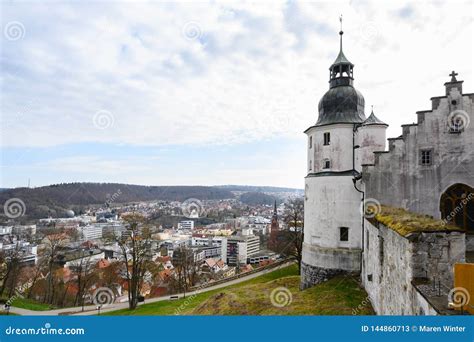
[{"left": 0, "top": 183, "right": 234, "bottom": 220}]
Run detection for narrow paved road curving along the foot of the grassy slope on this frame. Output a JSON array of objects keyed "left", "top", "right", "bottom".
[{"left": 10, "top": 261, "right": 294, "bottom": 316}]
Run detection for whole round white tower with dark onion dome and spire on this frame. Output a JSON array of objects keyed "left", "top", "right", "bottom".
[{"left": 301, "top": 19, "right": 387, "bottom": 288}]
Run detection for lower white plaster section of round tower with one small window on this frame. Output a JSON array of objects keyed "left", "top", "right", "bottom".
[{"left": 303, "top": 176, "right": 362, "bottom": 270}]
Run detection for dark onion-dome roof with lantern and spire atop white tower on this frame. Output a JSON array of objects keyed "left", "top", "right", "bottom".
[{"left": 316, "top": 19, "right": 366, "bottom": 126}]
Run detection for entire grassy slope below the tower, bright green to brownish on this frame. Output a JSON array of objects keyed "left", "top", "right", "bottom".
[{"left": 109, "top": 265, "right": 373, "bottom": 315}]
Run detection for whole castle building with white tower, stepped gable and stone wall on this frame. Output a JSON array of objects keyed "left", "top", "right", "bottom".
[{"left": 301, "top": 22, "right": 474, "bottom": 304}]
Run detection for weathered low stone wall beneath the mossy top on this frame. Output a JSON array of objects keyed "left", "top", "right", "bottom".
[{"left": 361, "top": 220, "right": 465, "bottom": 315}]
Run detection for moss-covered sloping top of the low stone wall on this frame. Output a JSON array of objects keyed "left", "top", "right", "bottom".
[{"left": 373, "top": 205, "right": 465, "bottom": 237}]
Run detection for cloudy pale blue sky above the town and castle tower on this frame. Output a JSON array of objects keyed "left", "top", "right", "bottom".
[{"left": 0, "top": 0, "right": 474, "bottom": 188}]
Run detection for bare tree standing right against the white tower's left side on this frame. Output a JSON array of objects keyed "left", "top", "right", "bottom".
[{"left": 284, "top": 198, "right": 304, "bottom": 271}]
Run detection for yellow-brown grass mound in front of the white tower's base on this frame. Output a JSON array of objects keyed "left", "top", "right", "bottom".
[{"left": 190, "top": 276, "right": 373, "bottom": 316}]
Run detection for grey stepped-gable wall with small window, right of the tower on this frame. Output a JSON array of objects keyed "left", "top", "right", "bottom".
[{"left": 362, "top": 86, "right": 474, "bottom": 218}]
